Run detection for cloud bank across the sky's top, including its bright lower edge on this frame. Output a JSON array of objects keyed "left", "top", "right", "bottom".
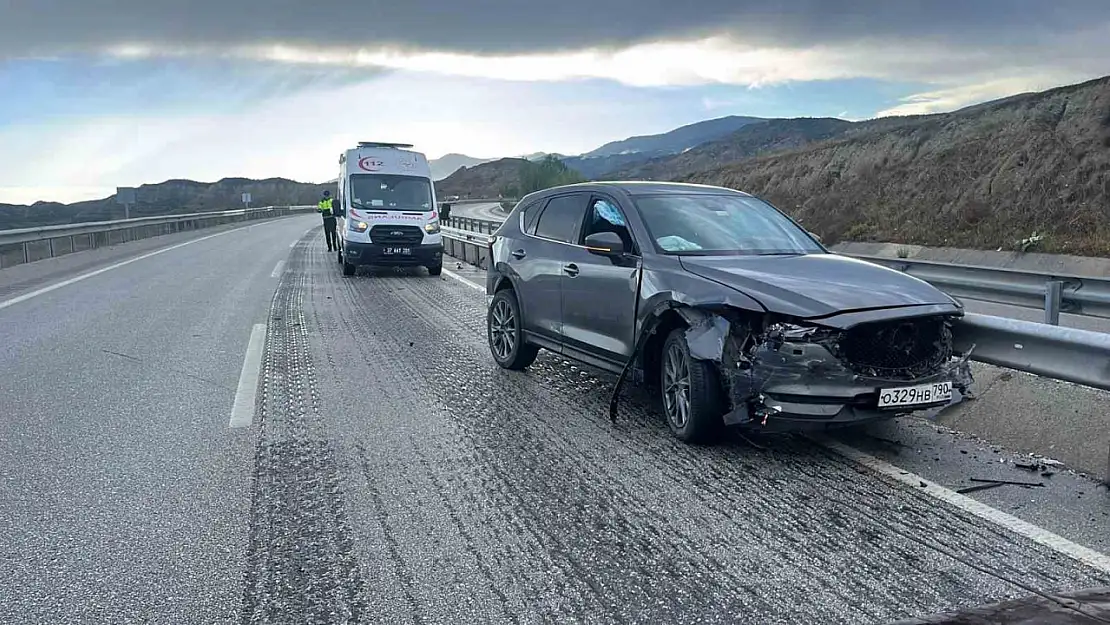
[{"left": 0, "top": 0, "right": 1110, "bottom": 87}]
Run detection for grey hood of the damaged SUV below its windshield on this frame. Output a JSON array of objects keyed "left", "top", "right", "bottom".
[{"left": 680, "top": 254, "right": 956, "bottom": 319}]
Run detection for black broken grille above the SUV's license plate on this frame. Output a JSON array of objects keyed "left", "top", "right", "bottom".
[{"left": 840, "top": 317, "right": 952, "bottom": 380}]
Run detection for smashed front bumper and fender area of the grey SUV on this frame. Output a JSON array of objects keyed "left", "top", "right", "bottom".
[{"left": 657, "top": 308, "right": 973, "bottom": 430}]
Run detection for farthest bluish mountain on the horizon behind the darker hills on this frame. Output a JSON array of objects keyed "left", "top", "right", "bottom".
[{"left": 563, "top": 115, "right": 766, "bottom": 179}]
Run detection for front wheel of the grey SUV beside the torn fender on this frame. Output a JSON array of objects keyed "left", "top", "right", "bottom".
[{"left": 659, "top": 327, "right": 725, "bottom": 444}]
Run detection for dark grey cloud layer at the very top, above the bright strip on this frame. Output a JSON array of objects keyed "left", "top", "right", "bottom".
[{"left": 0, "top": 0, "right": 1110, "bottom": 54}]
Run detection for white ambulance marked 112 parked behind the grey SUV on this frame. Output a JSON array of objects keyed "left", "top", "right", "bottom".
[{"left": 333, "top": 141, "right": 443, "bottom": 275}]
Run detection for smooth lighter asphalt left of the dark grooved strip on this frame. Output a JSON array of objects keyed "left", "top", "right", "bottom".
[{"left": 0, "top": 218, "right": 319, "bottom": 625}]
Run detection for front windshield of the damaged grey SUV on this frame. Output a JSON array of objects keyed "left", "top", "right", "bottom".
[{"left": 636, "top": 194, "right": 825, "bottom": 255}]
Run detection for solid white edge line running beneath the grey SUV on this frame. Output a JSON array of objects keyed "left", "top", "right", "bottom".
[{"left": 443, "top": 261, "right": 1110, "bottom": 573}]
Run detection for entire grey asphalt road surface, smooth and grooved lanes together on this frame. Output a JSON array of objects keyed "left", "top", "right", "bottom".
[{"left": 0, "top": 218, "right": 1110, "bottom": 624}]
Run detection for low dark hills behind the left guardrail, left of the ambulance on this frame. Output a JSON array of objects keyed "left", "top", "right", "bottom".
[{"left": 0, "top": 178, "right": 332, "bottom": 230}]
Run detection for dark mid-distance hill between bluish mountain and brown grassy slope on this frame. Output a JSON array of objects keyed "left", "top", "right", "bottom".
[{"left": 596, "top": 118, "right": 867, "bottom": 180}]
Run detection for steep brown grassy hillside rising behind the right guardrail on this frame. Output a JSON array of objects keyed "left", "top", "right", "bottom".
[{"left": 673, "top": 77, "right": 1110, "bottom": 255}]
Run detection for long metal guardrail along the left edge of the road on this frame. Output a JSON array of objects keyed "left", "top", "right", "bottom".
[{"left": 0, "top": 206, "right": 315, "bottom": 269}]
